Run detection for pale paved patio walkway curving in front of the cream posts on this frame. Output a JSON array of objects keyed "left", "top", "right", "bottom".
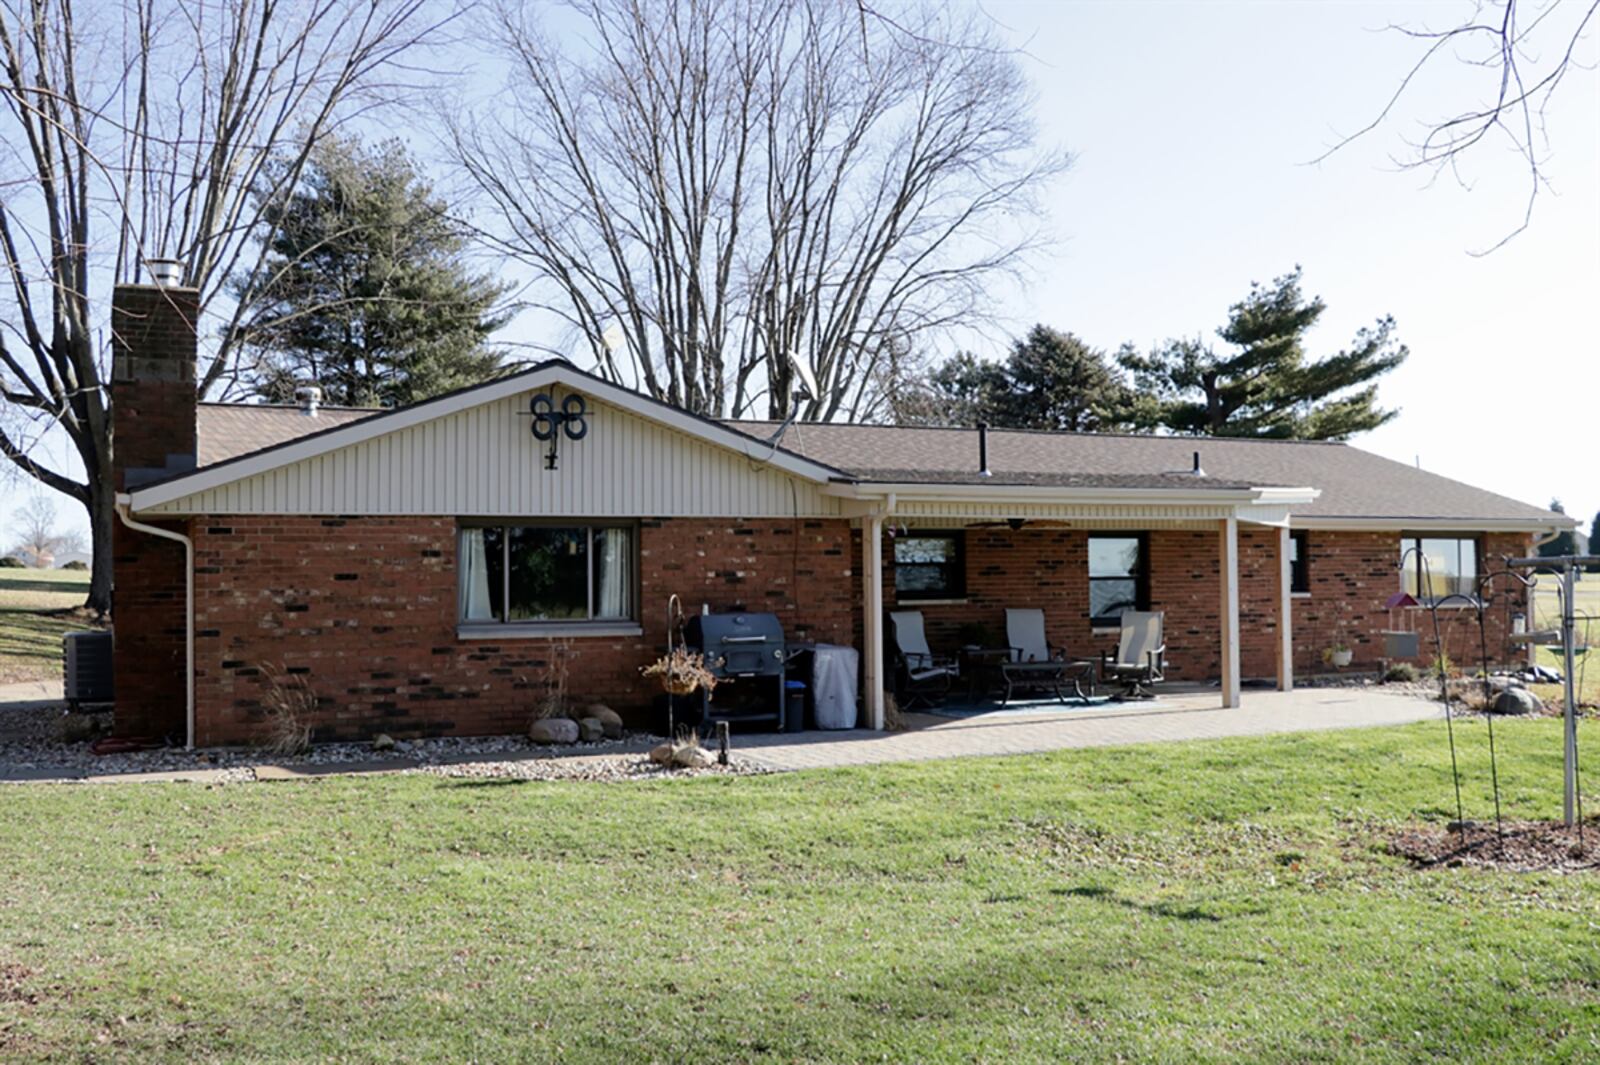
[{"left": 734, "top": 688, "right": 1445, "bottom": 769}]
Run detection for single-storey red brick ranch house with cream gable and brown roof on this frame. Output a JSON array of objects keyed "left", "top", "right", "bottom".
[{"left": 112, "top": 286, "right": 1566, "bottom": 745}]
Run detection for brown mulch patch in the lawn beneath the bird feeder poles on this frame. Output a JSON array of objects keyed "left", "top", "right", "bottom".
[{"left": 1389, "top": 820, "right": 1600, "bottom": 873}]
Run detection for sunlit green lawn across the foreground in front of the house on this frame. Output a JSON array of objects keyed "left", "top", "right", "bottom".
[{"left": 0, "top": 720, "right": 1600, "bottom": 1063}]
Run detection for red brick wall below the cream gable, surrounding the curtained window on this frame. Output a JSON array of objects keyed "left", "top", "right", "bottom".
[{"left": 194, "top": 517, "right": 858, "bottom": 745}]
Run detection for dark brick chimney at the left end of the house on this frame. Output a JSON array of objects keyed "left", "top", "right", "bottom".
[{"left": 110, "top": 285, "right": 200, "bottom": 742}]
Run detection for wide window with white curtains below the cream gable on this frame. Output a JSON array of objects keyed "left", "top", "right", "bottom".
[{"left": 456, "top": 523, "right": 638, "bottom": 625}]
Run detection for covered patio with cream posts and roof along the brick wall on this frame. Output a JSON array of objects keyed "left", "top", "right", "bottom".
[{"left": 838, "top": 472, "right": 1317, "bottom": 729}]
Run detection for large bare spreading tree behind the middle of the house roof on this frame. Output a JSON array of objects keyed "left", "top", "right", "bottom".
[{"left": 453, "top": 0, "right": 1067, "bottom": 419}]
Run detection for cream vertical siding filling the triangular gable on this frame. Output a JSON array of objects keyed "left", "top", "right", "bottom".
[{"left": 147, "top": 390, "right": 838, "bottom": 518}]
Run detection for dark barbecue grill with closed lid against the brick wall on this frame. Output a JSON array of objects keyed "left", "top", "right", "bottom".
[{"left": 683, "top": 614, "right": 787, "bottom": 729}]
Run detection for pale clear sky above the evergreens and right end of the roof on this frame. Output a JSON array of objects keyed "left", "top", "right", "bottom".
[{"left": 0, "top": 0, "right": 1600, "bottom": 534}]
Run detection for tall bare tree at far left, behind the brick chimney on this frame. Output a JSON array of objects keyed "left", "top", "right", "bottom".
[{"left": 0, "top": 0, "right": 438, "bottom": 611}]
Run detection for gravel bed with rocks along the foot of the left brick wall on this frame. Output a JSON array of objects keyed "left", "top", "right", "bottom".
[{"left": 0, "top": 705, "right": 765, "bottom": 784}]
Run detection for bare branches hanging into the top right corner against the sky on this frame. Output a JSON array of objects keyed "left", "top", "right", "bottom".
[{"left": 1314, "top": 0, "right": 1600, "bottom": 251}]
